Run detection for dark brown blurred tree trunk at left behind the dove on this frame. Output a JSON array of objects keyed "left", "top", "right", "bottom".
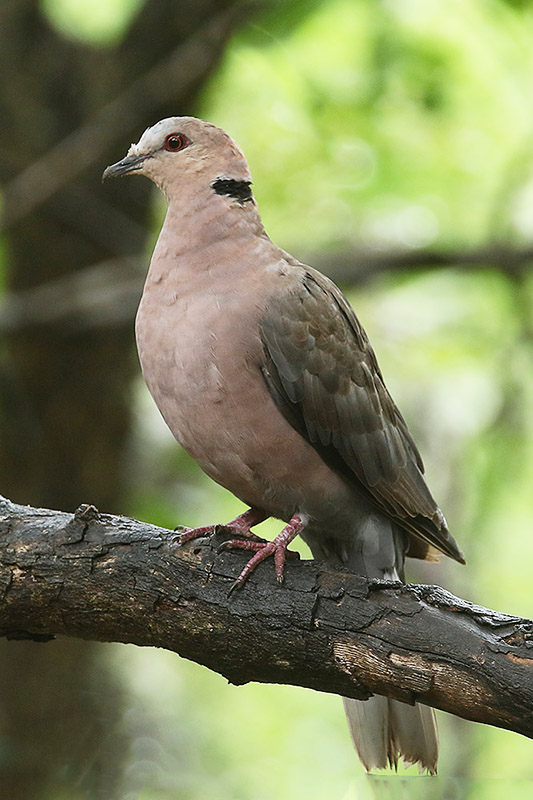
[{"left": 0, "top": 0, "right": 256, "bottom": 800}]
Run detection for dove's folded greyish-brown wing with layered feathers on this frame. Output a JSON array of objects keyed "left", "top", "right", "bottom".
[{"left": 261, "top": 266, "right": 464, "bottom": 562}]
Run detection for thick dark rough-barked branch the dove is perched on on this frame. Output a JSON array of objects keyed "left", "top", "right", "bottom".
[{"left": 0, "top": 499, "right": 533, "bottom": 738}]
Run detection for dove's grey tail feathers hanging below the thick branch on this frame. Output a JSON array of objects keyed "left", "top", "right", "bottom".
[{"left": 343, "top": 695, "right": 438, "bottom": 775}]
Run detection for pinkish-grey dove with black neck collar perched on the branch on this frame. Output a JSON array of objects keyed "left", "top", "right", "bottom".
[{"left": 103, "top": 116, "right": 465, "bottom": 774}]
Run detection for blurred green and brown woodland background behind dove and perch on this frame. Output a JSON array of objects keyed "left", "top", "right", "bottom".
[{"left": 0, "top": 0, "right": 533, "bottom": 800}]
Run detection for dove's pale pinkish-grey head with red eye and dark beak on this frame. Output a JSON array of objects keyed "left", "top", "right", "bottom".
[{"left": 102, "top": 117, "right": 252, "bottom": 201}]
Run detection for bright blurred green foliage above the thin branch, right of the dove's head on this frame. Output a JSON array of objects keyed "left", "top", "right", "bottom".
[{"left": 202, "top": 0, "right": 533, "bottom": 252}]
